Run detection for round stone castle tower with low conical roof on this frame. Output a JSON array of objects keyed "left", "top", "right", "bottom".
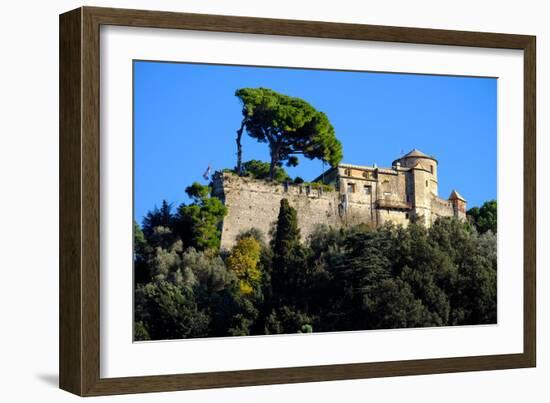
[{"left": 393, "top": 149, "right": 438, "bottom": 226}]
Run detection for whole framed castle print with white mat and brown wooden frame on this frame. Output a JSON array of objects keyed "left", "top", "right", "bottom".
[{"left": 60, "top": 7, "right": 536, "bottom": 396}]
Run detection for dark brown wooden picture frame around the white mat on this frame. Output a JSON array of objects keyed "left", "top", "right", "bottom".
[{"left": 59, "top": 7, "right": 536, "bottom": 396}]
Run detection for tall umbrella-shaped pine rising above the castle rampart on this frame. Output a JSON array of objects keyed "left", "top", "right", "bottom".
[{"left": 235, "top": 88, "right": 342, "bottom": 179}]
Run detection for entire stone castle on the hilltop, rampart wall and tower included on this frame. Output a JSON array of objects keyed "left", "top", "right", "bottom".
[{"left": 213, "top": 149, "right": 466, "bottom": 249}]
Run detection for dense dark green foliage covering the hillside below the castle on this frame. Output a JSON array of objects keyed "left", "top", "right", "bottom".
[{"left": 134, "top": 193, "right": 497, "bottom": 340}]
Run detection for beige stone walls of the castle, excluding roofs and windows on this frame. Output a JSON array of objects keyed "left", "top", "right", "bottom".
[{"left": 212, "top": 170, "right": 465, "bottom": 249}]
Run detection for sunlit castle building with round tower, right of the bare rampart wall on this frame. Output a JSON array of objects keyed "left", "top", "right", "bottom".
[{"left": 314, "top": 149, "right": 466, "bottom": 227}]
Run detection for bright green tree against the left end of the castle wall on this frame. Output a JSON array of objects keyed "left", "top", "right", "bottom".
[{"left": 175, "top": 182, "right": 227, "bottom": 250}]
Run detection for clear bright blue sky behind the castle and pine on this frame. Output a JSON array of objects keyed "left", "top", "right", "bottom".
[{"left": 134, "top": 61, "right": 497, "bottom": 222}]
